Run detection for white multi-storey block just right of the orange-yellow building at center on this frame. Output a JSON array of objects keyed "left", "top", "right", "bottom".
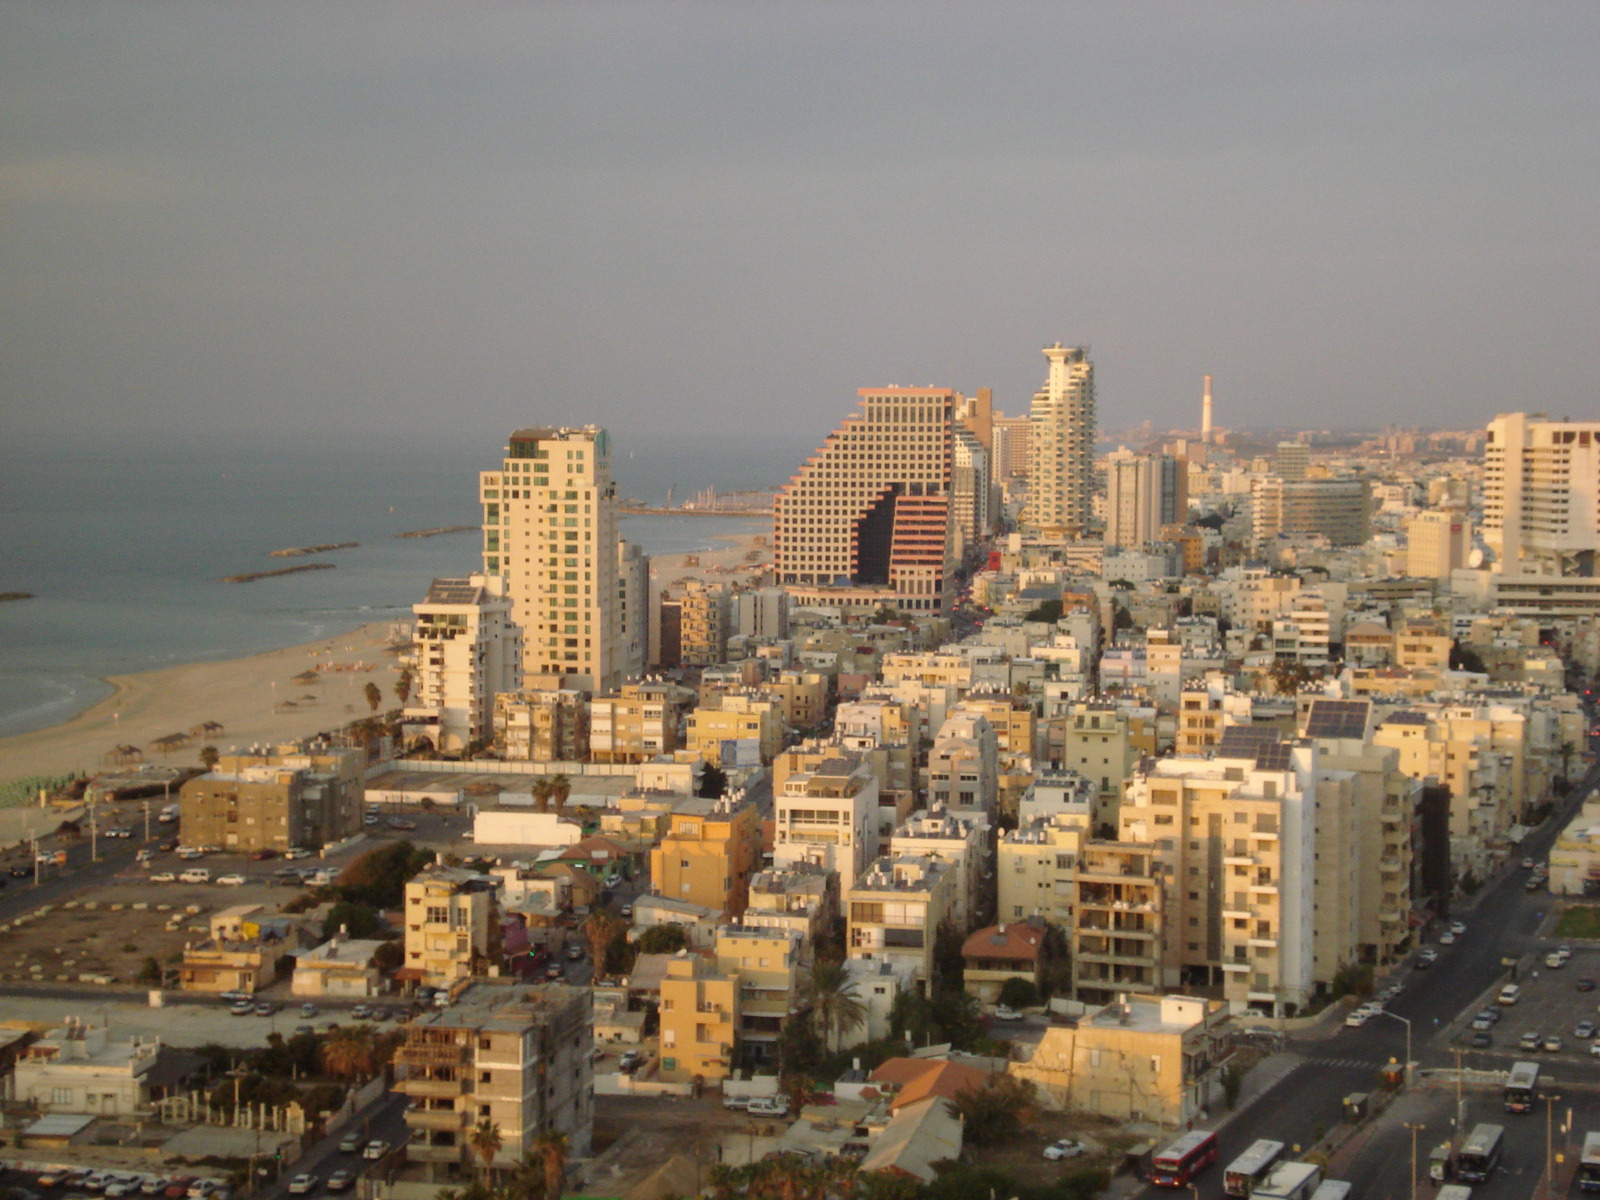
[{"left": 773, "top": 755, "right": 878, "bottom": 893}]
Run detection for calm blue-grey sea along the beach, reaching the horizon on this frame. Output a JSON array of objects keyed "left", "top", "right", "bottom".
[{"left": 0, "top": 445, "right": 780, "bottom": 736}]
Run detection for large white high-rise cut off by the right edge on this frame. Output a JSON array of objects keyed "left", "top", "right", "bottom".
[{"left": 1483, "top": 413, "right": 1600, "bottom": 576}]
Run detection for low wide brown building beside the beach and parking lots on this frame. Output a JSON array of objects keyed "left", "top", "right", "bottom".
[{"left": 178, "top": 746, "right": 366, "bottom": 854}]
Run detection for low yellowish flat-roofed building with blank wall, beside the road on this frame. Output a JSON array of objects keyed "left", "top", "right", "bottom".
[{"left": 1006, "top": 995, "right": 1232, "bottom": 1128}]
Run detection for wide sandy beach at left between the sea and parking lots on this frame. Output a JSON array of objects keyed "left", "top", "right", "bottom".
[{"left": 0, "top": 622, "right": 400, "bottom": 781}]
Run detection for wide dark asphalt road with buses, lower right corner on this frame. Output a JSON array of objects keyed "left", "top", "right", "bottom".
[{"left": 1141, "top": 766, "right": 1600, "bottom": 1200}]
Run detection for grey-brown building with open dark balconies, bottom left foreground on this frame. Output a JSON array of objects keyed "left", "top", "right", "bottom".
[{"left": 392, "top": 979, "right": 594, "bottom": 1184}]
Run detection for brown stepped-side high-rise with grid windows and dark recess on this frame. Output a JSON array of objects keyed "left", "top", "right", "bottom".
[{"left": 773, "top": 387, "right": 957, "bottom": 613}]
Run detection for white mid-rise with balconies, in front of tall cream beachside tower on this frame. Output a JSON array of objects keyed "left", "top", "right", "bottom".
[{"left": 400, "top": 574, "right": 522, "bottom": 750}]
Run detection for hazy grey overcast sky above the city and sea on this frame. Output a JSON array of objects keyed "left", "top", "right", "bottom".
[{"left": 0, "top": 0, "right": 1600, "bottom": 445}]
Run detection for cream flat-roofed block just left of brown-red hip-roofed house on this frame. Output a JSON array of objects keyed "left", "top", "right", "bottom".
[{"left": 845, "top": 854, "right": 955, "bottom": 987}]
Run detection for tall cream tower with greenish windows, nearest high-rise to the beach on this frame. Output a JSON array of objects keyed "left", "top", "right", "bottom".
[{"left": 478, "top": 426, "right": 627, "bottom": 694}]
